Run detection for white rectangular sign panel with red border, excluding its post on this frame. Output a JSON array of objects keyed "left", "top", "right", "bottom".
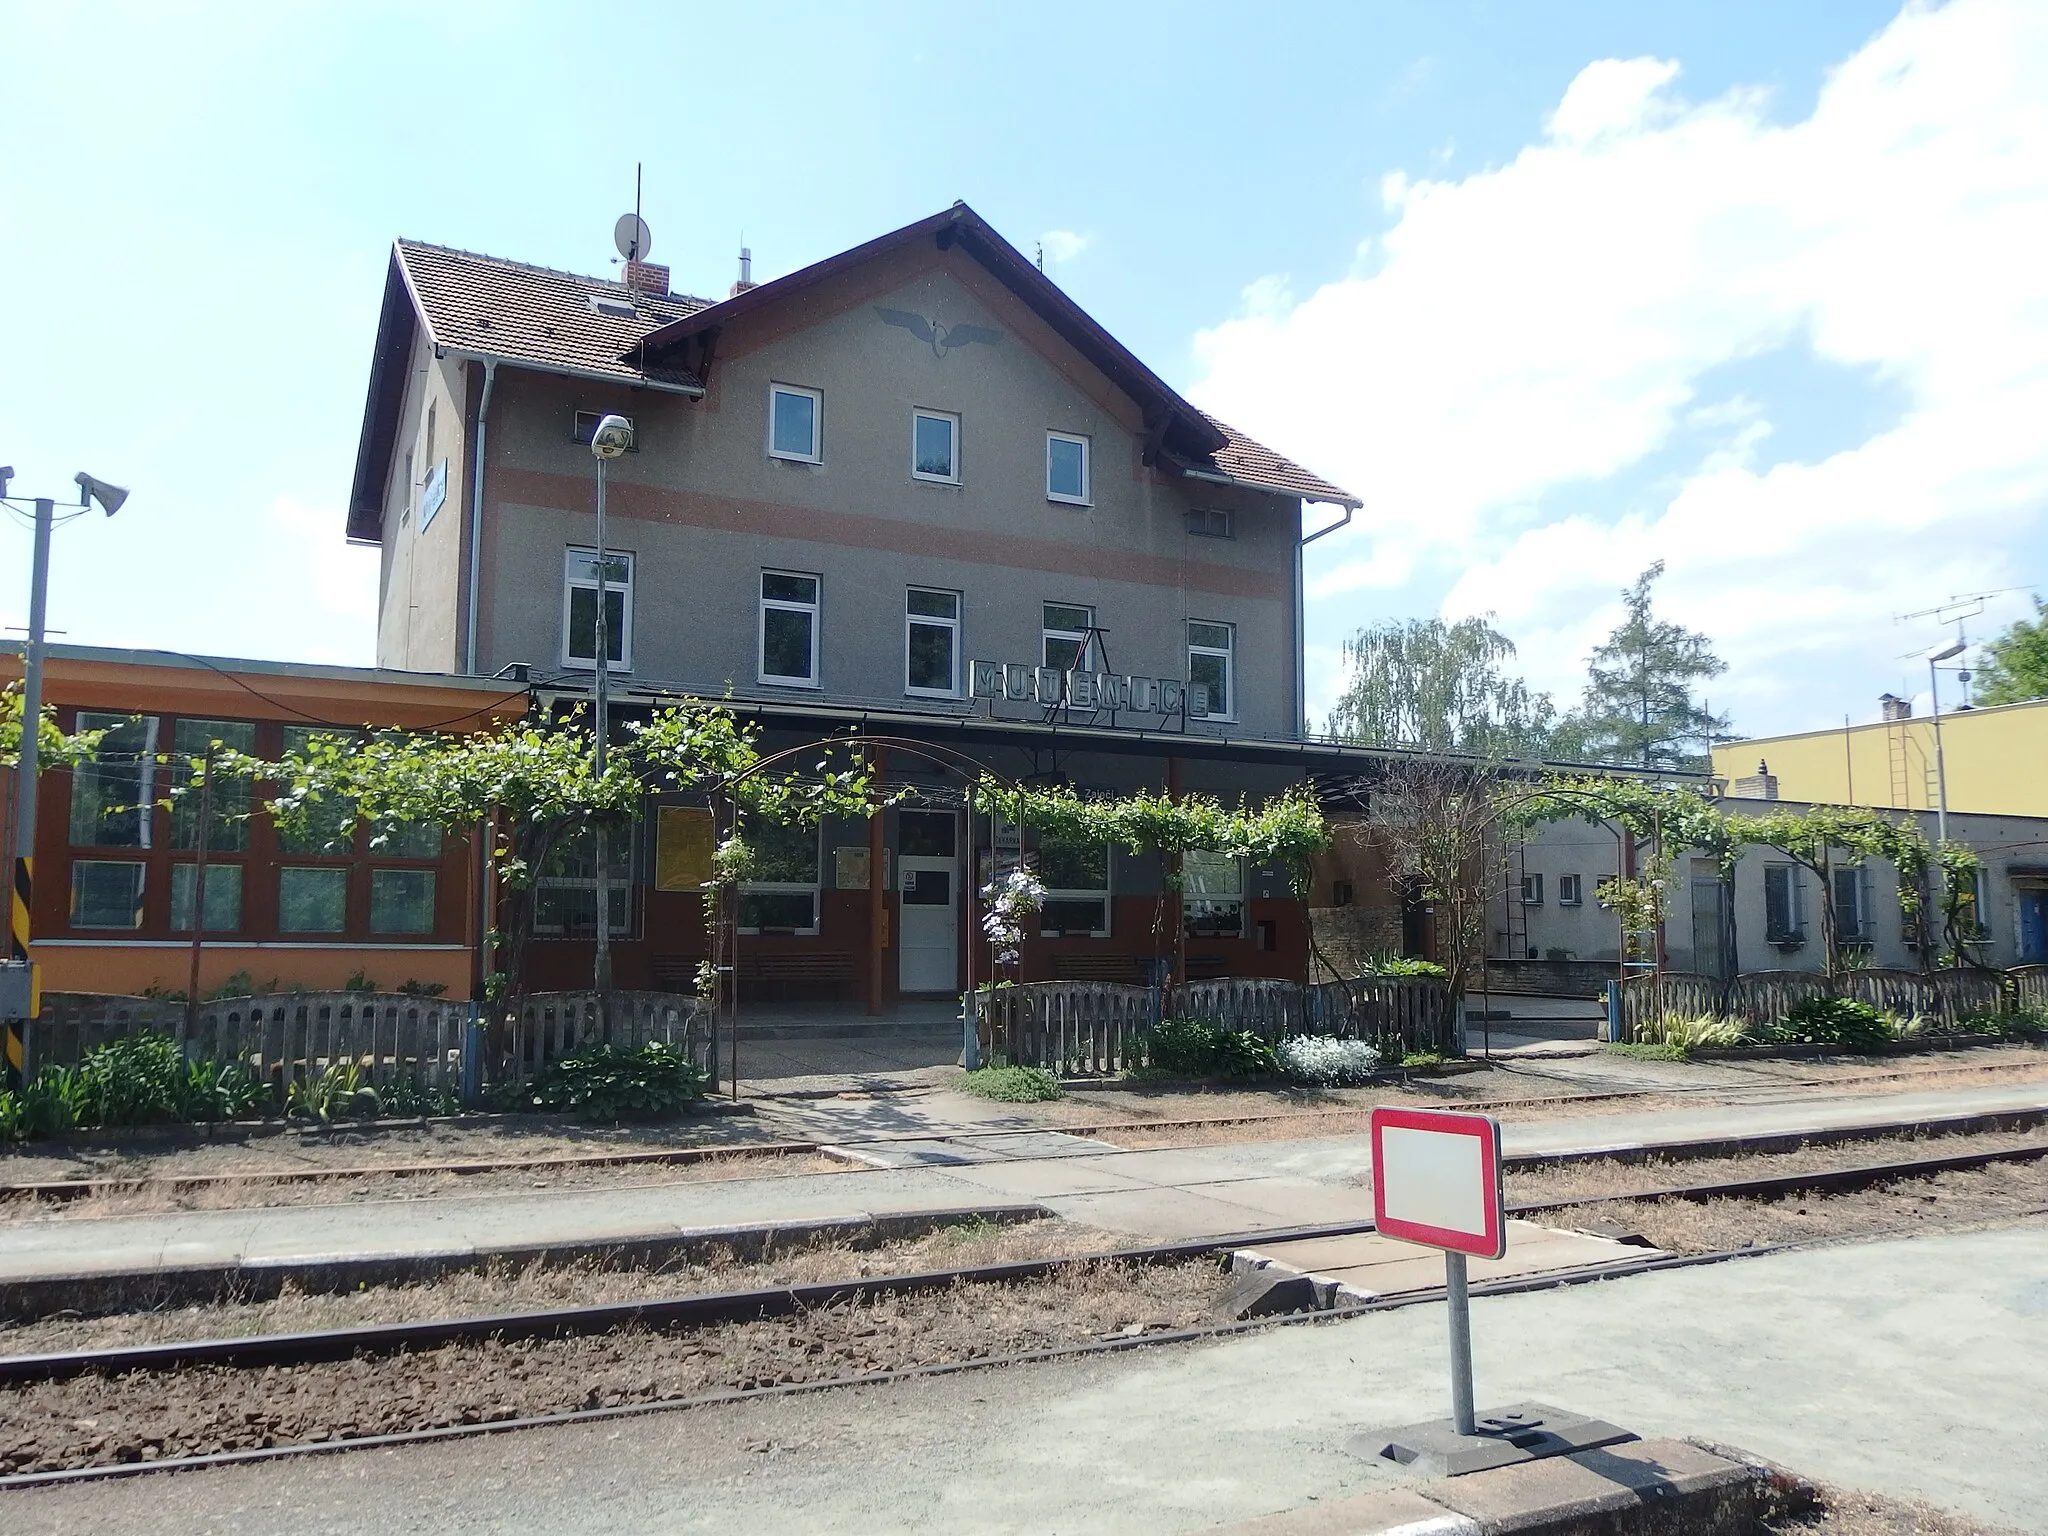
[{"left": 1372, "top": 1108, "right": 1507, "bottom": 1260}]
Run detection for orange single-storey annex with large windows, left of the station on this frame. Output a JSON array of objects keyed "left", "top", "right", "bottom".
[{"left": 0, "top": 643, "right": 528, "bottom": 997}]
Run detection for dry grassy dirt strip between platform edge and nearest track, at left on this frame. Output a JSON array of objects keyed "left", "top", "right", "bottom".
[{"left": 0, "top": 1221, "right": 1139, "bottom": 1354}]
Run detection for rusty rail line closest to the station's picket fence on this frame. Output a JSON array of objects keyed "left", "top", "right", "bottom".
[{"left": 0, "top": 1063, "right": 2039, "bottom": 1202}]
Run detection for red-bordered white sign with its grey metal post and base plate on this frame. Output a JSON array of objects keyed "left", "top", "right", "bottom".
[{"left": 1352, "top": 1108, "right": 1634, "bottom": 1477}]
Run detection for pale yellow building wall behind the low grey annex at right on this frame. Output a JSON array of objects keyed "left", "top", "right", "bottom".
[{"left": 1714, "top": 698, "right": 2048, "bottom": 815}]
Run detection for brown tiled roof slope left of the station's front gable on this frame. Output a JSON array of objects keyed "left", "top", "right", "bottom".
[{"left": 395, "top": 240, "right": 711, "bottom": 385}]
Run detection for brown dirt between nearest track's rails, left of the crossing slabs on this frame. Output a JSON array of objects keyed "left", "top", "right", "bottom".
[{"left": 0, "top": 1264, "right": 1223, "bottom": 1475}]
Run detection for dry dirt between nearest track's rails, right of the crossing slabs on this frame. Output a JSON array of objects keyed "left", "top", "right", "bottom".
[{"left": 1542, "top": 1161, "right": 2048, "bottom": 1253}]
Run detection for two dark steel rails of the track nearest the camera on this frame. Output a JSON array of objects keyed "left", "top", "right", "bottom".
[{"left": 0, "top": 1143, "right": 2048, "bottom": 1489}]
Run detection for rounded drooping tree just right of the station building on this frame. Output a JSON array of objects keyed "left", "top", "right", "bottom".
[{"left": 1327, "top": 614, "right": 1556, "bottom": 758}]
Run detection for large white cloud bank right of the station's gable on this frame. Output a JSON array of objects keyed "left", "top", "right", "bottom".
[{"left": 1192, "top": 0, "right": 2048, "bottom": 729}]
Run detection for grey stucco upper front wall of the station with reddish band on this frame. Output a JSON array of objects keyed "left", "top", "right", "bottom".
[{"left": 460, "top": 258, "right": 1300, "bottom": 735}]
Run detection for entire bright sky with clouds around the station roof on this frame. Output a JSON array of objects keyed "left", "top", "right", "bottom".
[{"left": 0, "top": 0, "right": 2048, "bottom": 731}]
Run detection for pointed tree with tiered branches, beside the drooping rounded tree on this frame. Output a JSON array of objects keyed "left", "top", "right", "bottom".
[{"left": 1556, "top": 561, "right": 1729, "bottom": 770}]
